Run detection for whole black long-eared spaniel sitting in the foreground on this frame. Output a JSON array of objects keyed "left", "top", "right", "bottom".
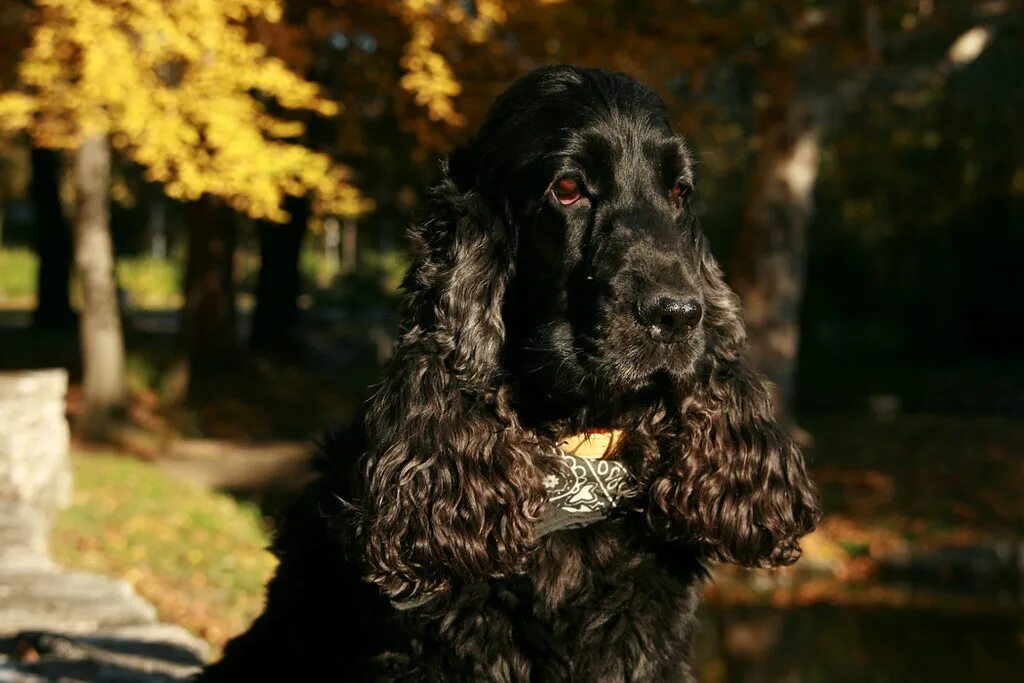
[{"left": 203, "top": 67, "right": 818, "bottom": 681}]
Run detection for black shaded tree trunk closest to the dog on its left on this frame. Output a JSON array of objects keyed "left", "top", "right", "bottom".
[{"left": 249, "top": 192, "right": 310, "bottom": 353}]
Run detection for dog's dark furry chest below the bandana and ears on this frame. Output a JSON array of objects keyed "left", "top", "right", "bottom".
[{"left": 387, "top": 522, "right": 700, "bottom": 681}]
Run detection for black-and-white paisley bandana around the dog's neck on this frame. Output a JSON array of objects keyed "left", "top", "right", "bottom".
[{"left": 537, "top": 451, "right": 629, "bottom": 538}]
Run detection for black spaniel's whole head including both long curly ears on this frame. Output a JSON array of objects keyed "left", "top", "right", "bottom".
[{"left": 358, "top": 67, "right": 817, "bottom": 596}]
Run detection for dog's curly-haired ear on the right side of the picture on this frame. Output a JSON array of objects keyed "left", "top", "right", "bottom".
[{"left": 647, "top": 237, "right": 819, "bottom": 566}]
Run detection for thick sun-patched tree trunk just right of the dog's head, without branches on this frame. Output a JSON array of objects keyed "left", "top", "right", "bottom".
[{"left": 730, "top": 65, "right": 822, "bottom": 413}]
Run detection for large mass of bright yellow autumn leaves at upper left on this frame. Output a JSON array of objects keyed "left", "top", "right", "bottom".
[{"left": 0, "top": 0, "right": 369, "bottom": 220}]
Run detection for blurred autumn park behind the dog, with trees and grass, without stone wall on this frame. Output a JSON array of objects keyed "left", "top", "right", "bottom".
[{"left": 0, "top": 0, "right": 1024, "bottom": 683}]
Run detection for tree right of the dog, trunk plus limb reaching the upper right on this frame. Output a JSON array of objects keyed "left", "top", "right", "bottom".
[{"left": 729, "top": 1, "right": 1010, "bottom": 412}]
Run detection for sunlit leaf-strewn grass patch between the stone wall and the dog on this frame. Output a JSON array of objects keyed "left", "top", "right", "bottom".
[{"left": 52, "top": 453, "right": 275, "bottom": 648}]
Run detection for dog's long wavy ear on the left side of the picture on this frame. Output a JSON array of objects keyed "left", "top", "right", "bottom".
[{"left": 356, "top": 153, "right": 545, "bottom": 600}]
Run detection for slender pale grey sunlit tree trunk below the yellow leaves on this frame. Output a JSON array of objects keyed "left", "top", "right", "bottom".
[{"left": 74, "top": 135, "right": 125, "bottom": 436}]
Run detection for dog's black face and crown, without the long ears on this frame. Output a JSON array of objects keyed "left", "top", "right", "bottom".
[{"left": 452, "top": 68, "right": 720, "bottom": 419}]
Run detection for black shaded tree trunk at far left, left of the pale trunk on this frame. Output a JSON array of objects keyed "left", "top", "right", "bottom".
[{"left": 31, "top": 147, "right": 75, "bottom": 330}]
